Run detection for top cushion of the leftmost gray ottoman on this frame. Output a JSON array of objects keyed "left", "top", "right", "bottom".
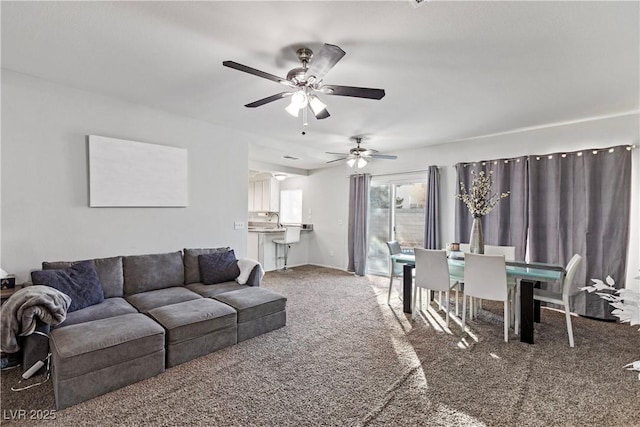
[{"left": 49, "top": 313, "right": 165, "bottom": 379}]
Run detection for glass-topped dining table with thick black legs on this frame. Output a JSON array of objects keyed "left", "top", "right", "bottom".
[{"left": 391, "top": 253, "right": 566, "bottom": 344}]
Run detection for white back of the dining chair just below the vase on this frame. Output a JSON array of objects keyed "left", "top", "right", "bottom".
[{"left": 464, "top": 253, "right": 508, "bottom": 301}]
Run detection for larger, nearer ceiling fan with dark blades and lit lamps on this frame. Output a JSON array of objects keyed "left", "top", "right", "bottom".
[{"left": 222, "top": 43, "right": 385, "bottom": 119}]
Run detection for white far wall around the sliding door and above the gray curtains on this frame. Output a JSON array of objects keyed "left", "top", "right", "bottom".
[{"left": 307, "top": 114, "right": 640, "bottom": 286}]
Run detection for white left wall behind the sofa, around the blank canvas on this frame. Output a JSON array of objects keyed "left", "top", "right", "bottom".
[{"left": 1, "top": 70, "right": 249, "bottom": 282}]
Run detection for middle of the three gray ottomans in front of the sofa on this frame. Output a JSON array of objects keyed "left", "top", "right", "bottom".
[{"left": 147, "top": 298, "right": 237, "bottom": 368}]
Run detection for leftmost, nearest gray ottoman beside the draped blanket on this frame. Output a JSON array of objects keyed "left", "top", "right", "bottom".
[{"left": 49, "top": 313, "right": 164, "bottom": 409}]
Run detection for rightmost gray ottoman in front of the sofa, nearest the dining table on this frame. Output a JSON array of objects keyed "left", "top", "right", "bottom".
[{"left": 213, "top": 287, "right": 287, "bottom": 342}]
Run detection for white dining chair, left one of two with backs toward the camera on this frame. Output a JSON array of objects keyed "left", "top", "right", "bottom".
[{"left": 412, "top": 248, "right": 457, "bottom": 327}]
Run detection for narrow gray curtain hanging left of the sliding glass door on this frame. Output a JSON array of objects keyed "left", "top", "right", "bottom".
[{"left": 347, "top": 173, "right": 371, "bottom": 276}]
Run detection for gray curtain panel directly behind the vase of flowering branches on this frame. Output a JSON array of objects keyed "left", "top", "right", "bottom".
[{"left": 455, "top": 157, "right": 529, "bottom": 261}]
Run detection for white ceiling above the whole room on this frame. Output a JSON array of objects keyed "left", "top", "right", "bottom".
[{"left": 1, "top": 0, "right": 640, "bottom": 169}]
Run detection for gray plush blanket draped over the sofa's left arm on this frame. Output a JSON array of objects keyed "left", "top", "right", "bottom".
[{"left": 0, "top": 285, "right": 71, "bottom": 353}]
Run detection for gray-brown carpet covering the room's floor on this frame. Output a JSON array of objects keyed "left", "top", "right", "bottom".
[{"left": 1, "top": 267, "right": 640, "bottom": 426}]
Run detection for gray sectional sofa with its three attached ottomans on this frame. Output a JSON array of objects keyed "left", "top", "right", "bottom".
[{"left": 32, "top": 248, "right": 286, "bottom": 409}]
